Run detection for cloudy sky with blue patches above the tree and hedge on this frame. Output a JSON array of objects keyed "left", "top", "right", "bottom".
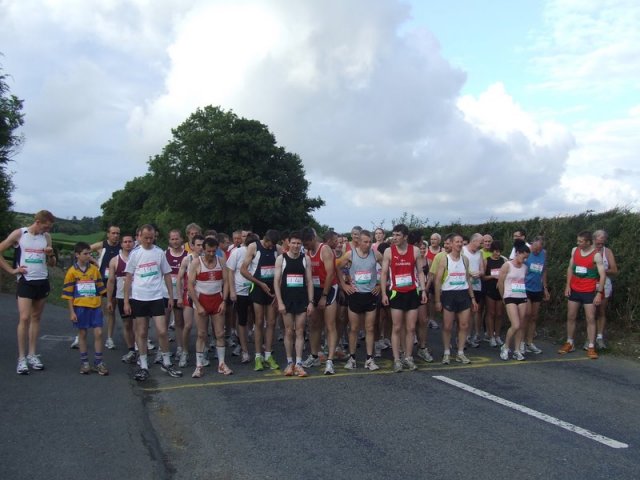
[{"left": 0, "top": 0, "right": 640, "bottom": 231}]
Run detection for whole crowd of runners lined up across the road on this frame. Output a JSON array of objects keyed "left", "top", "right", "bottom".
[{"left": 0, "top": 211, "right": 617, "bottom": 381}]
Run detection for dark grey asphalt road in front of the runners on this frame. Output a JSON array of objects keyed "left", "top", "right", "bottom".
[{"left": 0, "top": 295, "right": 640, "bottom": 480}]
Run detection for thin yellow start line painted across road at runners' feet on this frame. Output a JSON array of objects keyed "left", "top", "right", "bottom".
[{"left": 142, "top": 357, "right": 590, "bottom": 393}]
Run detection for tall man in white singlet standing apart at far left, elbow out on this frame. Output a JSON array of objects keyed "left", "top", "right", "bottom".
[{"left": 0, "top": 210, "right": 56, "bottom": 375}]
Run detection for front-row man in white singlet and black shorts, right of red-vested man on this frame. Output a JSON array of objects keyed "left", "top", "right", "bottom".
[{"left": 432, "top": 234, "right": 478, "bottom": 365}]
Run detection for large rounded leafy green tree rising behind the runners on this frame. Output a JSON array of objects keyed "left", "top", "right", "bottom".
[{"left": 102, "top": 106, "right": 324, "bottom": 237}]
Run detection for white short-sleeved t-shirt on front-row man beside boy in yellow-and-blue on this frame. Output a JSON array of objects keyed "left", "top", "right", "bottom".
[{"left": 124, "top": 245, "right": 171, "bottom": 301}]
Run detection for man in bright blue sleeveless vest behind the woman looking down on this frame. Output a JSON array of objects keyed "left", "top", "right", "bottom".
[{"left": 520, "top": 236, "right": 549, "bottom": 355}]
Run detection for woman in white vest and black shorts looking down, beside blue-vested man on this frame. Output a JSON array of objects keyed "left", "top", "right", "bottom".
[{"left": 498, "top": 240, "right": 530, "bottom": 361}]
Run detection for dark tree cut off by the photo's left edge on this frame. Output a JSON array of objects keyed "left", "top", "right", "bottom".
[{"left": 0, "top": 62, "right": 24, "bottom": 237}]
